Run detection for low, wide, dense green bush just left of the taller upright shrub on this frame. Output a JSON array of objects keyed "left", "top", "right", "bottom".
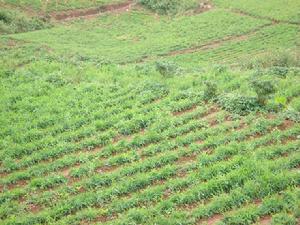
[{"left": 217, "top": 94, "right": 261, "bottom": 115}]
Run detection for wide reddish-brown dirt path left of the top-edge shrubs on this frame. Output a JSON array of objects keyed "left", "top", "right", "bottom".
[{"left": 50, "top": 0, "right": 134, "bottom": 21}]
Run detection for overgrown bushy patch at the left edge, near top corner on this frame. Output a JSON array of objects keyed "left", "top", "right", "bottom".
[{"left": 0, "top": 9, "right": 50, "bottom": 34}]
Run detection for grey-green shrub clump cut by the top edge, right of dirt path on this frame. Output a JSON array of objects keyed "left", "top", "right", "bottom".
[{"left": 139, "top": 0, "right": 199, "bottom": 14}]
